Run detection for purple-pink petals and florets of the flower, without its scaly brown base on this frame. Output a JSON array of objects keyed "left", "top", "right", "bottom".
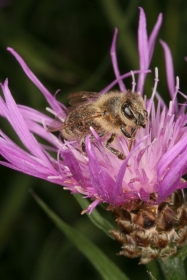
[{"left": 0, "top": 8, "right": 187, "bottom": 212}]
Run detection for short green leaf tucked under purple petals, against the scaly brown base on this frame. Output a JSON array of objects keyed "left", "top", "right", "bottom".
[{"left": 74, "top": 194, "right": 114, "bottom": 239}]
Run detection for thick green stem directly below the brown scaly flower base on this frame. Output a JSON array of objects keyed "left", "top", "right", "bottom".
[{"left": 159, "top": 257, "right": 186, "bottom": 280}]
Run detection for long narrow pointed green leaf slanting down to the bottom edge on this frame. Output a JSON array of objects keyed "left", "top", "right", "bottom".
[{"left": 31, "top": 192, "right": 129, "bottom": 280}]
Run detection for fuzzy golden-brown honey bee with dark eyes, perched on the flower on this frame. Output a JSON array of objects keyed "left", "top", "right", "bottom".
[{"left": 48, "top": 90, "right": 147, "bottom": 160}]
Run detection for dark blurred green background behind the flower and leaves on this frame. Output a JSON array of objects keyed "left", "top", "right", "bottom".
[{"left": 0, "top": 0, "right": 187, "bottom": 280}]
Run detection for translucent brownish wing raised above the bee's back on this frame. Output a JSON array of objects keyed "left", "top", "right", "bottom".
[{"left": 68, "top": 91, "right": 101, "bottom": 106}]
